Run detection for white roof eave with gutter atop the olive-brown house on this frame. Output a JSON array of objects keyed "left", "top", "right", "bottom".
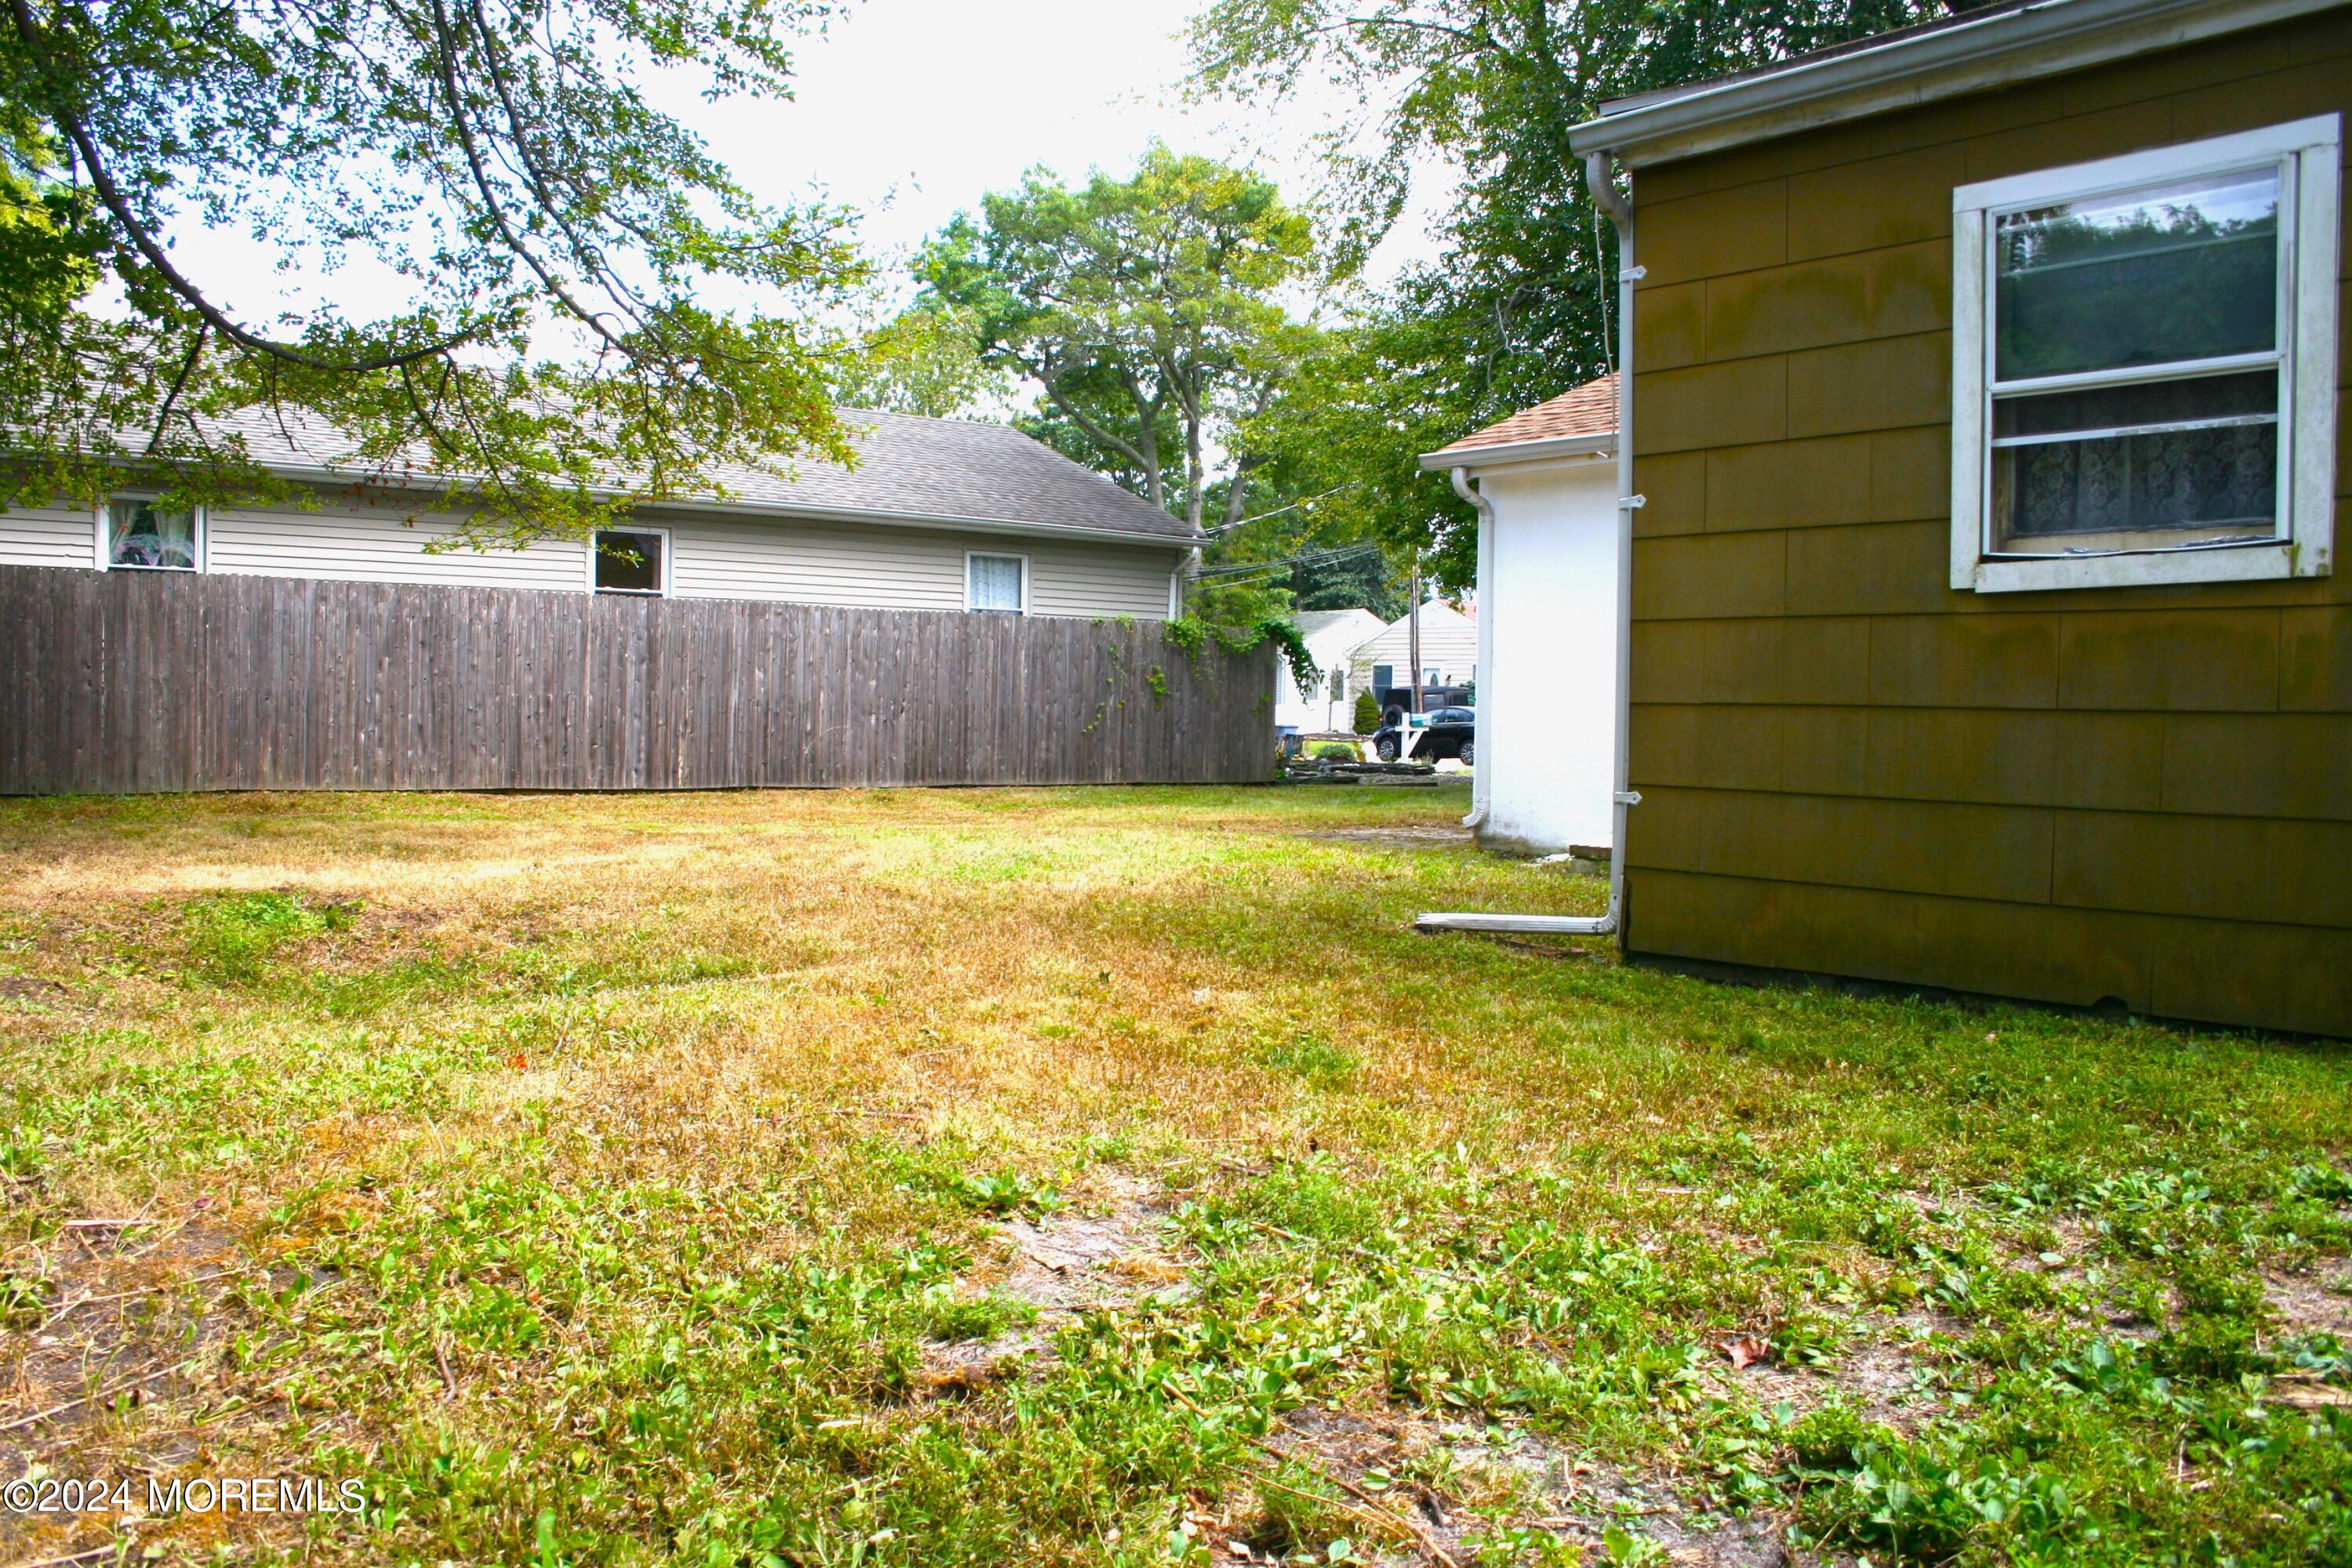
[{"left": 1569, "top": 0, "right": 2345, "bottom": 167}]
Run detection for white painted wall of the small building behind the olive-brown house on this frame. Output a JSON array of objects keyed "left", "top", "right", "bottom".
[{"left": 1477, "top": 459, "right": 1616, "bottom": 853}]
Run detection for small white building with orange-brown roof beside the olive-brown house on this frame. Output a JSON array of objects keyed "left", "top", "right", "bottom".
[{"left": 1421, "top": 376, "right": 1618, "bottom": 853}]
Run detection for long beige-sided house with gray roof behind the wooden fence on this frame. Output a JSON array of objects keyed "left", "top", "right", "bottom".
[{"left": 0, "top": 409, "right": 1195, "bottom": 621}]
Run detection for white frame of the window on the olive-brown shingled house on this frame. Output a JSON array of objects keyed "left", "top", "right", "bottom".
[{"left": 1952, "top": 115, "right": 2343, "bottom": 593}]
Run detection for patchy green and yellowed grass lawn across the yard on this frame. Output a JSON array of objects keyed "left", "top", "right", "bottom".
[{"left": 0, "top": 787, "right": 2352, "bottom": 1568}]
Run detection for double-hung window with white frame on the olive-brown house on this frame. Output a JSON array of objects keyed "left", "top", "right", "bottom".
[{"left": 1952, "top": 115, "right": 2340, "bottom": 593}]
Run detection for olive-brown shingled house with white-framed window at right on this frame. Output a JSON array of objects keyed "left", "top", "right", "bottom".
[{"left": 1573, "top": 0, "right": 2352, "bottom": 1034}]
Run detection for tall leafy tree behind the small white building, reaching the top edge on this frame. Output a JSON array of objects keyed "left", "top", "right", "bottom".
[{"left": 1190, "top": 0, "right": 1945, "bottom": 583}]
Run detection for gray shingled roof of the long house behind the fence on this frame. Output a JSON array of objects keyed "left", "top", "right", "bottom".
[{"left": 198, "top": 409, "right": 1192, "bottom": 543}]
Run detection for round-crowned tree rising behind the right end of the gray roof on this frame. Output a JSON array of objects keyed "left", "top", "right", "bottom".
[{"left": 920, "top": 146, "right": 1315, "bottom": 540}]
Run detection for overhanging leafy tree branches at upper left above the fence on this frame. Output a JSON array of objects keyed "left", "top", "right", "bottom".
[{"left": 0, "top": 0, "right": 856, "bottom": 539}]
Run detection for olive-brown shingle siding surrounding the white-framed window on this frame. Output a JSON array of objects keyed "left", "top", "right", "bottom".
[{"left": 1625, "top": 9, "right": 2352, "bottom": 1034}]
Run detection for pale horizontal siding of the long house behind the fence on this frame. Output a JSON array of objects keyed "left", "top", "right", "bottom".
[{"left": 0, "top": 501, "right": 1181, "bottom": 621}]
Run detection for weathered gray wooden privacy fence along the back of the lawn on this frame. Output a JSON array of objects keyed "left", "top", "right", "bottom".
[{"left": 0, "top": 567, "right": 1275, "bottom": 794}]
